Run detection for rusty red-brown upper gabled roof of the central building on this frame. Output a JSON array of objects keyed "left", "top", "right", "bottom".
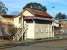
[{"left": 23, "top": 8, "right": 52, "bottom": 18}]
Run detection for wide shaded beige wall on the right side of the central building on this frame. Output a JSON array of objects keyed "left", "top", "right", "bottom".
[{"left": 35, "top": 24, "right": 54, "bottom": 39}]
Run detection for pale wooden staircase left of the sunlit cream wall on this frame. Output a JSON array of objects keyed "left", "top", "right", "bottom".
[{"left": 13, "top": 25, "right": 27, "bottom": 41}]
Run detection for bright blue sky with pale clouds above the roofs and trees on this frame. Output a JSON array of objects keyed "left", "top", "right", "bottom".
[{"left": 1, "top": 0, "right": 67, "bottom": 16}]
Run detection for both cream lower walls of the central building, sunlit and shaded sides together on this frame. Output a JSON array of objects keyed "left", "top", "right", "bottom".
[{"left": 25, "top": 23, "right": 54, "bottom": 39}]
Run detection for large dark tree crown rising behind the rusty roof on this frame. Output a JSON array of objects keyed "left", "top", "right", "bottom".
[{"left": 23, "top": 3, "right": 47, "bottom": 11}]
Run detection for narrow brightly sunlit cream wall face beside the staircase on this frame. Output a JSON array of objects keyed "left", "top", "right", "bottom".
[{"left": 25, "top": 23, "right": 35, "bottom": 39}]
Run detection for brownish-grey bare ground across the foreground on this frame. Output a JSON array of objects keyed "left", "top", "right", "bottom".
[{"left": 1, "top": 40, "right": 67, "bottom": 50}]
